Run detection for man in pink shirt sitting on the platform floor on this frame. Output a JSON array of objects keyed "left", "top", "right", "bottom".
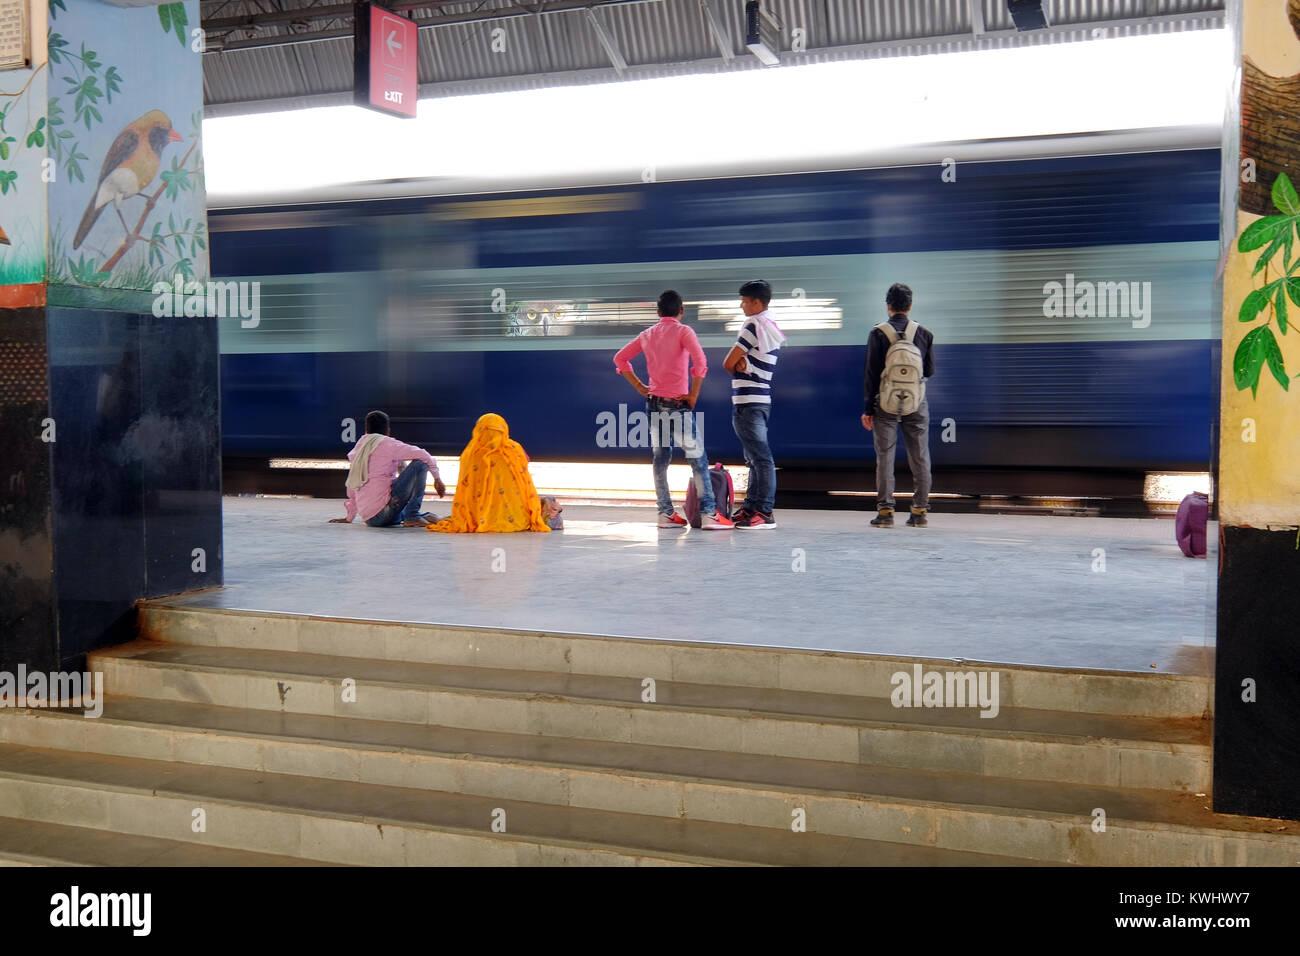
[{"left": 330, "top": 411, "right": 447, "bottom": 528}]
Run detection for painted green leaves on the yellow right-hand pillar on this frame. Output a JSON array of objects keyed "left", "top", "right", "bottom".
[{"left": 1232, "top": 173, "right": 1300, "bottom": 397}]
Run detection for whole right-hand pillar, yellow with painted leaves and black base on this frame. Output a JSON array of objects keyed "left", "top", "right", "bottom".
[{"left": 1214, "top": 0, "right": 1300, "bottom": 819}]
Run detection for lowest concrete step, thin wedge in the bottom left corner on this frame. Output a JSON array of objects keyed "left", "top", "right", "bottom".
[{"left": 0, "top": 817, "right": 343, "bottom": 866}]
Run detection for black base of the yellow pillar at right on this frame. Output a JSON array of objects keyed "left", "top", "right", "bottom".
[{"left": 1214, "top": 528, "right": 1300, "bottom": 819}]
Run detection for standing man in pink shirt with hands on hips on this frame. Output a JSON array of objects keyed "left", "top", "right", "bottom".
[{"left": 614, "top": 289, "right": 735, "bottom": 531}]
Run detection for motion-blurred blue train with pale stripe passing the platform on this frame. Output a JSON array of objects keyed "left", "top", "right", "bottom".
[{"left": 209, "top": 128, "right": 1221, "bottom": 494}]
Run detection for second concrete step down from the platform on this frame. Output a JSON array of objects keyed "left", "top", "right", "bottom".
[{"left": 92, "top": 641, "right": 1210, "bottom": 793}]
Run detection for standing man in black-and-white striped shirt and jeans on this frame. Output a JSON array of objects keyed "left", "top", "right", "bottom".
[{"left": 723, "top": 280, "right": 785, "bottom": 529}]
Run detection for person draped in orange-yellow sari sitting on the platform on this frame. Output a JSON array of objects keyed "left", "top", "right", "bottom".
[{"left": 425, "top": 412, "right": 550, "bottom": 533}]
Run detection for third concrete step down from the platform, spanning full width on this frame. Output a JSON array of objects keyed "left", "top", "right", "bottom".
[{"left": 0, "top": 698, "right": 1300, "bottom": 865}]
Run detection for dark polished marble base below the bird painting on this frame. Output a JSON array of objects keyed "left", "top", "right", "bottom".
[{"left": 0, "top": 306, "right": 222, "bottom": 670}]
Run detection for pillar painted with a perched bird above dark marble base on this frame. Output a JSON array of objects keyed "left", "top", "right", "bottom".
[{"left": 0, "top": 0, "right": 221, "bottom": 672}]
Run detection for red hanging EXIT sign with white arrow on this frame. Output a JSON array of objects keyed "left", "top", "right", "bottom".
[{"left": 354, "top": 4, "right": 419, "bottom": 116}]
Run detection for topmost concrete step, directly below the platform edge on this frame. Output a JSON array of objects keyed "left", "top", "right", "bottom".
[{"left": 139, "top": 598, "right": 1212, "bottom": 718}]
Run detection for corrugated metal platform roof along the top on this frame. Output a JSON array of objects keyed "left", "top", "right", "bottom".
[{"left": 200, "top": 0, "right": 1225, "bottom": 116}]
